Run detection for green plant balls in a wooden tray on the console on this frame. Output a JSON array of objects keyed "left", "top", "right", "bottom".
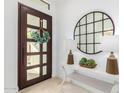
[{"left": 79, "top": 57, "right": 97, "bottom": 68}]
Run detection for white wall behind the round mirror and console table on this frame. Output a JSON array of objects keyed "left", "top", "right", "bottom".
[{"left": 56, "top": 0, "right": 119, "bottom": 77}]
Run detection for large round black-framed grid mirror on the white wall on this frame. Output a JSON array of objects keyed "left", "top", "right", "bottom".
[{"left": 74, "top": 11, "right": 115, "bottom": 54}]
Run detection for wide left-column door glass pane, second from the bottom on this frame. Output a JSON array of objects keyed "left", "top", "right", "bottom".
[{"left": 27, "top": 55, "right": 40, "bottom": 66}]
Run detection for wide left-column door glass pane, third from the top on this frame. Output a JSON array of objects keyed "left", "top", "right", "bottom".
[{"left": 27, "top": 42, "right": 40, "bottom": 52}]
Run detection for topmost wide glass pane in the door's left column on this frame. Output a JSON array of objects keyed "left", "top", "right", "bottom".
[{"left": 27, "top": 14, "right": 40, "bottom": 27}]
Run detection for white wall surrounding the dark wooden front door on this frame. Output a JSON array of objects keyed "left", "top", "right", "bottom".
[{"left": 4, "top": 0, "right": 56, "bottom": 93}]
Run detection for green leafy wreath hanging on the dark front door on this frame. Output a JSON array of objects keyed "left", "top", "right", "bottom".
[{"left": 30, "top": 31, "right": 50, "bottom": 44}]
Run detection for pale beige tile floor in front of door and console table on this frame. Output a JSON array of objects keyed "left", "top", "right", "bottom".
[{"left": 18, "top": 78, "right": 91, "bottom": 93}]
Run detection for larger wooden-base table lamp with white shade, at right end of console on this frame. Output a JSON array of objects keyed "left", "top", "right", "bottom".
[{"left": 101, "top": 35, "right": 119, "bottom": 75}]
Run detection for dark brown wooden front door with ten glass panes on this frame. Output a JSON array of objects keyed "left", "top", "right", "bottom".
[{"left": 18, "top": 4, "right": 52, "bottom": 89}]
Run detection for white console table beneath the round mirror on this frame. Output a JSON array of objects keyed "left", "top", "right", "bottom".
[{"left": 63, "top": 65, "right": 119, "bottom": 93}]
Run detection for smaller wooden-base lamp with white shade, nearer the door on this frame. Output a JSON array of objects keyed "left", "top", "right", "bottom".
[{"left": 65, "top": 39, "right": 76, "bottom": 65}]
